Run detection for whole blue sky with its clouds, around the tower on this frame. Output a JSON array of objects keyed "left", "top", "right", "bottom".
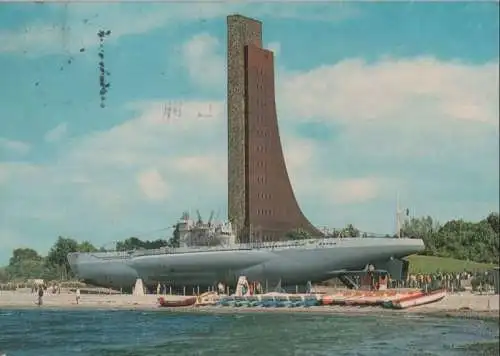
[{"left": 0, "top": 2, "right": 499, "bottom": 263}]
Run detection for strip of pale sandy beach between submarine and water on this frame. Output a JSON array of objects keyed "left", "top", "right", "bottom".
[{"left": 0, "top": 291, "right": 500, "bottom": 319}]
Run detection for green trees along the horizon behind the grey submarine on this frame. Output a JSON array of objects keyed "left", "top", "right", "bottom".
[{"left": 0, "top": 213, "right": 500, "bottom": 282}]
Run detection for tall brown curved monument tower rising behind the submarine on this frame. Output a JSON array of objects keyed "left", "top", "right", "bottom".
[{"left": 227, "top": 15, "right": 321, "bottom": 242}]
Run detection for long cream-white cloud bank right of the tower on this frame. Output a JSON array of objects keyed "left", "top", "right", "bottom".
[{"left": 280, "top": 57, "right": 498, "bottom": 126}]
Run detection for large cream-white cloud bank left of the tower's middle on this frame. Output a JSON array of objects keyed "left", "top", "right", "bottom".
[{"left": 0, "top": 100, "right": 227, "bottom": 221}]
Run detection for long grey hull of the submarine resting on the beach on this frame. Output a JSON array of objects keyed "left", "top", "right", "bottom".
[{"left": 68, "top": 238, "right": 424, "bottom": 292}]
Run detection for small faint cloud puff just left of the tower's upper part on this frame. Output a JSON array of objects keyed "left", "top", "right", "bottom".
[{"left": 182, "top": 33, "right": 225, "bottom": 88}]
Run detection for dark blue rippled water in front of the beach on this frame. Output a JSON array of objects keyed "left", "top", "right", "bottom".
[{"left": 0, "top": 309, "right": 499, "bottom": 356}]
